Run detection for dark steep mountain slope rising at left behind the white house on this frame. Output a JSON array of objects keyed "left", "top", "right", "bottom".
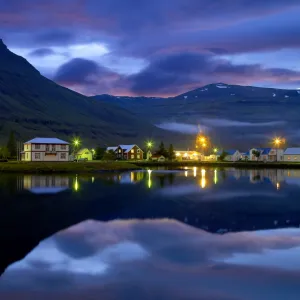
[{"left": 0, "top": 40, "right": 183, "bottom": 146}]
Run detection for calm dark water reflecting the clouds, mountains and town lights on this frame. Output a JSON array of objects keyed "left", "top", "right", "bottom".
[{"left": 0, "top": 168, "right": 300, "bottom": 300}]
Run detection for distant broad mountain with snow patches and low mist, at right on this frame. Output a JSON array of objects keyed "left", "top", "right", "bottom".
[{"left": 94, "top": 83, "right": 300, "bottom": 150}]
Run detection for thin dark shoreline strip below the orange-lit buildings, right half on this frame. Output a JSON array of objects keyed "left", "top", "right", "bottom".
[{"left": 135, "top": 161, "right": 300, "bottom": 169}]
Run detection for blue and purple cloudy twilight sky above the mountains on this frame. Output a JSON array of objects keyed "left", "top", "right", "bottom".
[{"left": 0, "top": 0, "right": 300, "bottom": 96}]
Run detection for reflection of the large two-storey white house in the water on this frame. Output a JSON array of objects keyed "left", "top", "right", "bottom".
[{"left": 23, "top": 175, "right": 70, "bottom": 194}]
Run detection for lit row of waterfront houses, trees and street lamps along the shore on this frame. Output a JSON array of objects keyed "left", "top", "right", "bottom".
[{"left": 0, "top": 133, "right": 300, "bottom": 163}]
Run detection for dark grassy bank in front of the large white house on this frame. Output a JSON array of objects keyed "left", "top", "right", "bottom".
[{"left": 0, "top": 161, "right": 140, "bottom": 173}]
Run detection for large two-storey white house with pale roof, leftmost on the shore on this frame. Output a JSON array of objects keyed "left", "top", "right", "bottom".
[{"left": 21, "top": 138, "right": 69, "bottom": 162}]
